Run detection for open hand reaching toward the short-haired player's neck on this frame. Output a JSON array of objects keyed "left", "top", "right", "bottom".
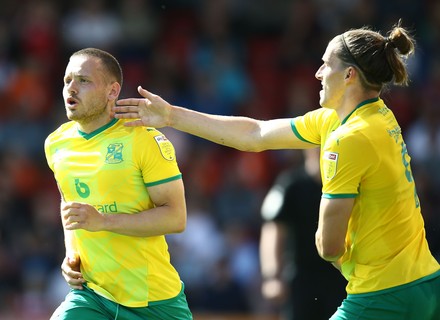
[{"left": 113, "top": 86, "right": 171, "bottom": 128}]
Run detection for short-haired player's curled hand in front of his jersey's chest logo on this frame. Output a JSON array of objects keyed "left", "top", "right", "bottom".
[{"left": 61, "top": 202, "right": 105, "bottom": 232}]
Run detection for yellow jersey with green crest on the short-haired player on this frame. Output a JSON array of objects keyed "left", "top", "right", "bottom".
[{"left": 45, "top": 119, "right": 182, "bottom": 307}]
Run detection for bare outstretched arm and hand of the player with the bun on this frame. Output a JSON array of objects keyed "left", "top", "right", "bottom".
[{"left": 113, "top": 87, "right": 315, "bottom": 152}]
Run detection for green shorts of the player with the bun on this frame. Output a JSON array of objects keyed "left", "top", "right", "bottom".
[{"left": 330, "top": 272, "right": 440, "bottom": 320}]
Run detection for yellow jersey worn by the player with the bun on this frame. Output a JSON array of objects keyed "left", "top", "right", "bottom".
[{"left": 292, "top": 98, "right": 440, "bottom": 293}]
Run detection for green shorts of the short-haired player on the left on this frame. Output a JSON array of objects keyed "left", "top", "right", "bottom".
[{"left": 50, "top": 283, "right": 193, "bottom": 320}]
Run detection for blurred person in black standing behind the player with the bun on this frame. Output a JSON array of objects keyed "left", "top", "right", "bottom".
[{"left": 260, "top": 148, "right": 346, "bottom": 320}]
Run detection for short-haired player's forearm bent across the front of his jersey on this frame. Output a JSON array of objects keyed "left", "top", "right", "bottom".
[{"left": 102, "top": 206, "right": 186, "bottom": 237}]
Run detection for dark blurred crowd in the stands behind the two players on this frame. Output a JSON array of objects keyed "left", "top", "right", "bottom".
[{"left": 0, "top": 0, "right": 440, "bottom": 319}]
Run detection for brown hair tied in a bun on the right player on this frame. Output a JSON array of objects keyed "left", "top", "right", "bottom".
[{"left": 336, "top": 20, "right": 415, "bottom": 91}]
